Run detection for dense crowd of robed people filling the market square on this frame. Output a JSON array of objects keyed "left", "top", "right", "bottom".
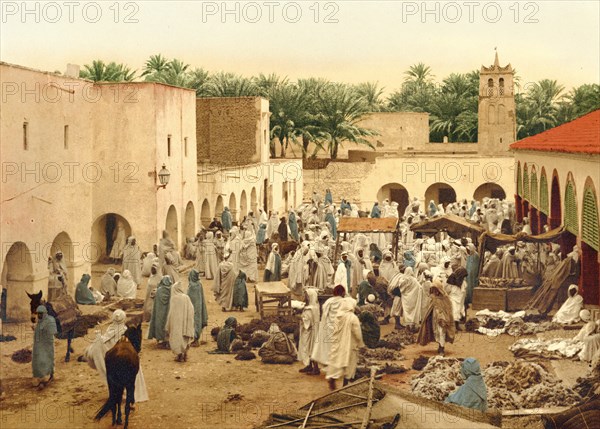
[{"left": 29, "top": 190, "right": 600, "bottom": 407}]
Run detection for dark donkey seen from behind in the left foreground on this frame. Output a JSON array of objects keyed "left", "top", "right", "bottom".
[{"left": 94, "top": 323, "right": 142, "bottom": 429}]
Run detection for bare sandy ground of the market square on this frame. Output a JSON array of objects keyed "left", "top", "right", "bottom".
[{"left": 0, "top": 264, "right": 586, "bottom": 429}]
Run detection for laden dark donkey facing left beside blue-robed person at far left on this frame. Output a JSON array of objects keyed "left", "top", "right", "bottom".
[{"left": 25, "top": 291, "right": 81, "bottom": 362}]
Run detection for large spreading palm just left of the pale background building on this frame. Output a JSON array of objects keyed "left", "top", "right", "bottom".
[{"left": 316, "top": 84, "right": 378, "bottom": 159}]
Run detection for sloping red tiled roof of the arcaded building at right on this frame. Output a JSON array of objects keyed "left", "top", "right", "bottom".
[{"left": 510, "top": 110, "right": 600, "bottom": 154}]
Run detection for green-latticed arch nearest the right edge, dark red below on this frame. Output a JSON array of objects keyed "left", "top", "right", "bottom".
[{"left": 580, "top": 177, "right": 600, "bottom": 305}]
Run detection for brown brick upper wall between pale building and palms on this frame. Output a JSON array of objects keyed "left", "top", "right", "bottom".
[{"left": 196, "top": 97, "right": 260, "bottom": 165}]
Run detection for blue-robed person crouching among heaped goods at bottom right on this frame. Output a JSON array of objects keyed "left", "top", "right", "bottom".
[{"left": 444, "top": 357, "right": 487, "bottom": 411}]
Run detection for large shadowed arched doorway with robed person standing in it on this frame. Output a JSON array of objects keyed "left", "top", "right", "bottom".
[{"left": 89, "top": 213, "right": 133, "bottom": 264}]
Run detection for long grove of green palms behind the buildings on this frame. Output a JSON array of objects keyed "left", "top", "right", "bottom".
[{"left": 80, "top": 54, "right": 600, "bottom": 159}]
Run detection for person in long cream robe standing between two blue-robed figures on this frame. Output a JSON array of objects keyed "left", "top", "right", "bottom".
[{"left": 165, "top": 282, "right": 194, "bottom": 362}]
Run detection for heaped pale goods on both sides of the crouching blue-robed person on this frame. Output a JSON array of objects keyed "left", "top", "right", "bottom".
[{"left": 411, "top": 356, "right": 581, "bottom": 409}]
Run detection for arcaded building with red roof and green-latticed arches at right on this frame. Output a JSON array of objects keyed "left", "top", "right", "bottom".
[{"left": 511, "top": 110, "right": 600, "bottom": 305}]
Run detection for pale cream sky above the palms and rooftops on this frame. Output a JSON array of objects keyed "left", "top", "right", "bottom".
[{"left": 0, "top": 0, "right": 600, "bottom": 93}]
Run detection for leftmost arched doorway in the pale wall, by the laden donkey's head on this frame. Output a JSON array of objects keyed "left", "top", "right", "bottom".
[{"left": 0, "top": 241, "right": 33, "bottom": 322}]
